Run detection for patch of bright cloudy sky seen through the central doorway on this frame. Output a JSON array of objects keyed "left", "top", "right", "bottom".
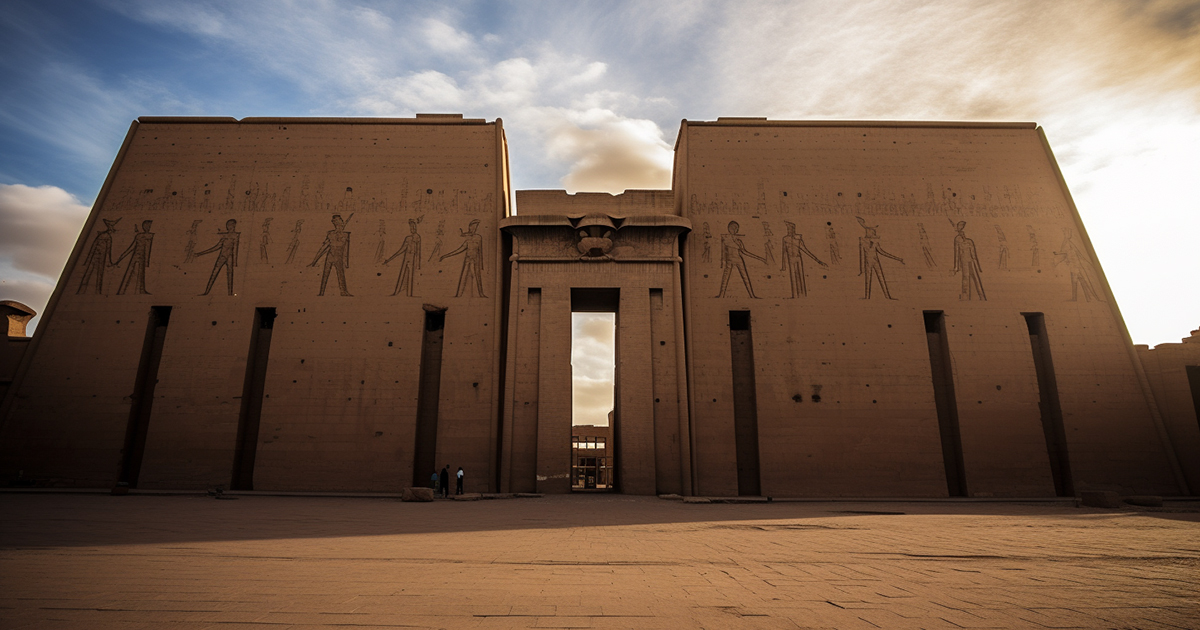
[{"left": 571, "top": 313, "right": 617, "bottom": 426}]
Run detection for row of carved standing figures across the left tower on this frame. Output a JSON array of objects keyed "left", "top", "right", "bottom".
[{"left": 76, "top": 214, "right": 487, "bottom": 298}]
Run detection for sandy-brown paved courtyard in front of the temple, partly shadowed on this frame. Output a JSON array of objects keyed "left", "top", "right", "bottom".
[{"left": 0, "top": 493, "right": 1200, "bottom": 629}]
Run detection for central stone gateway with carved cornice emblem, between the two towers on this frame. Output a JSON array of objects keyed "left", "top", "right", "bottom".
[{"left": 500, "top": 191, "right": 692, "bottom": 494}]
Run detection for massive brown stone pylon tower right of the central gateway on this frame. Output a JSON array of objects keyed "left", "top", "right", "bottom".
[{"left": 674, "top": 120, "right": 1178, "bottom": 497}]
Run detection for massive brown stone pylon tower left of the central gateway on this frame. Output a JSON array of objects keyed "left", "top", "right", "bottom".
[{"left": 0, "top": 116, "right": 508, "bottom": 490}]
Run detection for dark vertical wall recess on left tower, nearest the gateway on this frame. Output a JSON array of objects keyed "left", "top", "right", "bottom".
[{"left": 413, "top": 308, "right": 446, "bottom": 487}]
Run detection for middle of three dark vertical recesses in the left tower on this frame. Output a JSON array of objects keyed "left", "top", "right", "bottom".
[{"left": 229, "top": 308, "right": 275, "bottom": 490}]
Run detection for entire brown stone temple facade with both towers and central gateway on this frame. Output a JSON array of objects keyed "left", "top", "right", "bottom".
[{"left": 0, "top": 115, "right": 1200, "bottom": 497}]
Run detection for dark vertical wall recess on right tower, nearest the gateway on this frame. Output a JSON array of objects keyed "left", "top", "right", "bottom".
[{"left": 730, "top": 311, "right": 761, "bottom": 496}]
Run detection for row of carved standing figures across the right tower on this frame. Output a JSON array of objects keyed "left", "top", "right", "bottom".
[{"left": 701, "top": 217, "right": 1103, "bottom": 301}]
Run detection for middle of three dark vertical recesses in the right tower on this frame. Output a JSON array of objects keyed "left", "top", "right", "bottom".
[{"left": 924, "top": 311, "right": 967, "bottom": 497}]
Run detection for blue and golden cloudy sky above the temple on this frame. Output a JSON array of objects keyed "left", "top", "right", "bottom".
[{"left": 0, "top": 0, "right": 1200, "bottom": 422}]
